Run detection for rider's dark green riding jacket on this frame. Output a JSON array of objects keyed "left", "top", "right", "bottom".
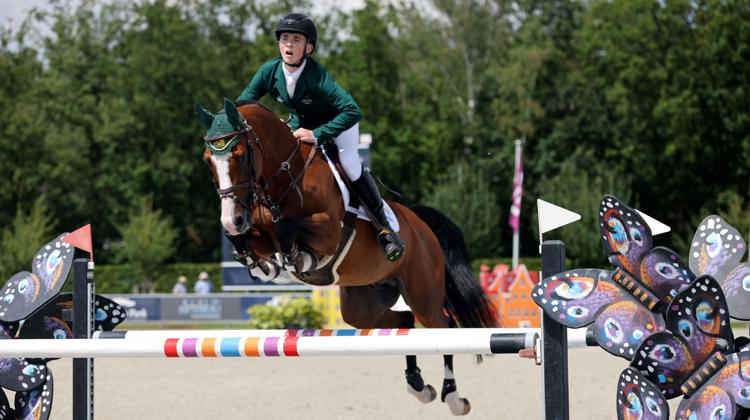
[{"left": 237, "top": 57, "right": 362, "bottom": 144}]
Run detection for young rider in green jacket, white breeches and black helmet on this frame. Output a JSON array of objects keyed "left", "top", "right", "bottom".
[{"left": 237, "top": 13, "right": 405, "bottom": 261}]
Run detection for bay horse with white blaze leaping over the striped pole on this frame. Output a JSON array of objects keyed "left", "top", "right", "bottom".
[{"left": 196, "top": 99, "right": 497, "bottom": 415}]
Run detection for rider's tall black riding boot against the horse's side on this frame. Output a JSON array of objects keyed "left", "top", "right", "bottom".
[{"left": 352, "top": 168, "right": 406, "bottom": 261}]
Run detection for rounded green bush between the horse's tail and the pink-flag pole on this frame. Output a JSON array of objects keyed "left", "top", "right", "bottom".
[{"left": 425, "top": 162, "right": 500, "bottom": 258}]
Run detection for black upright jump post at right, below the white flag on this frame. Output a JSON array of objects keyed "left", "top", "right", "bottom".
[{"left": 542, "top": 241, "right": 570, "bottom": 420}]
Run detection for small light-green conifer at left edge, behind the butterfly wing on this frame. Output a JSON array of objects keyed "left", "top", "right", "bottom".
[{"left": 0, "top": 197, "right": 55, "bottom": 279}]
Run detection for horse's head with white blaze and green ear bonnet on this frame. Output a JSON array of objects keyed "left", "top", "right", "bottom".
[{"left": 195, "top": 98, "right": 263, "bottom": 236}]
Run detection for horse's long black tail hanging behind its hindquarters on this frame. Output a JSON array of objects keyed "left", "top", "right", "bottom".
[{"left": 411, "top": 205, "right": 498, "bottom": 328}]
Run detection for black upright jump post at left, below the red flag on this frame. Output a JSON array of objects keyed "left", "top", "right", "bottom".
[{"left": 73, "top": 258, "right": 95, "bottom": 420}]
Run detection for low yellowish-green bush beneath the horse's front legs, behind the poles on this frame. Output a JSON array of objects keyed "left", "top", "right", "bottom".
[{"left": 247, "top": 298, "right": 325, "bottom": 329}]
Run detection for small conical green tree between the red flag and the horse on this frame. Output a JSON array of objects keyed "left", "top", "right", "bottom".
[{"left": 115, "top": 200, "right": 177, "bottom": 293}]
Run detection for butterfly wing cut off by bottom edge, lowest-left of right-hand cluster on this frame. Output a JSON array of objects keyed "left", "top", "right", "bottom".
[{"left": 617, "top": 367, "right": 669, "bottom": 420}]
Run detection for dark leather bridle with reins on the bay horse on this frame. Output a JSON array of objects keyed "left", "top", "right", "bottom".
[{"left": 203, "top": 121, "right": 318, "bottom": 223}]
